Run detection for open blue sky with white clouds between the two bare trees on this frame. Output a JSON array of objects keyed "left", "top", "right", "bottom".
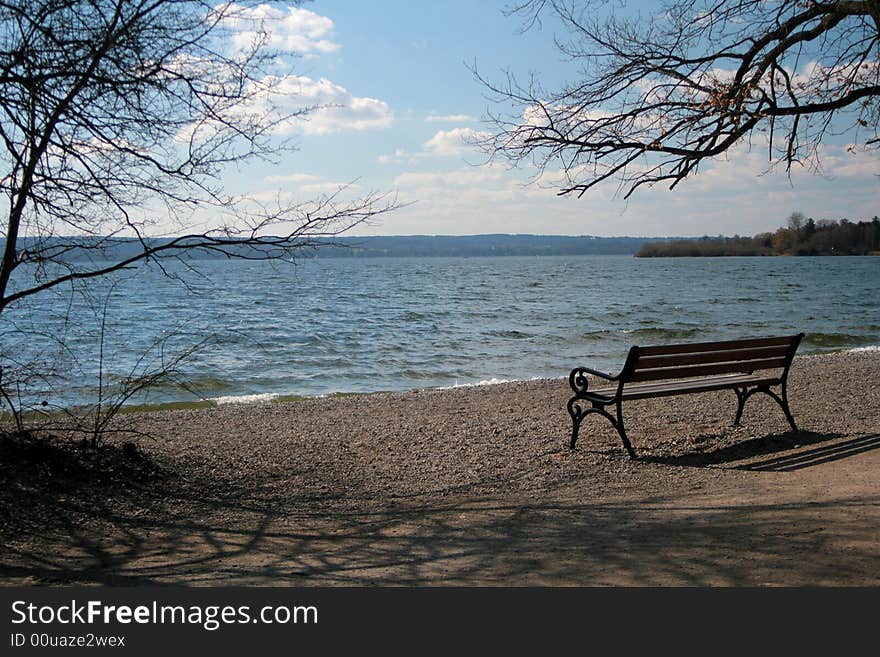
[{"left": 222, "top": 0, "right": 880, "bottom": 236}]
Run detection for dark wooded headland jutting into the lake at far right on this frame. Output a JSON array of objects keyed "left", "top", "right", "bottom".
[{"left": 636, "top": 212, "right": 880, "bottom": 258}]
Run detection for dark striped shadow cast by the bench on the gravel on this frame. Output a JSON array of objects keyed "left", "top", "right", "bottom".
[{"left": 639, "top": 431, "right": 880, "bottom": 472}]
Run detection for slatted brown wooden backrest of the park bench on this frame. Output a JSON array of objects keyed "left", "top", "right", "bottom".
[{"left": 620, "top": 333, "right": 804, "bottom": 382}]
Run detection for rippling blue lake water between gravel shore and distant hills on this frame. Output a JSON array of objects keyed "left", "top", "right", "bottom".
[{"left": 0, "top": 256, "right": 880, "bottom": 406}]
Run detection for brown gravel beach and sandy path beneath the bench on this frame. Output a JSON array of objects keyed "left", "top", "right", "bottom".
[{"left": 0, "top": 350, "right": 880, "bottom": 586}]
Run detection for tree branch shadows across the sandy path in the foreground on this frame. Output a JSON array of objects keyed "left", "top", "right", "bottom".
[{"left": 0, "top": 474, "right": 880, "bottom": 586}]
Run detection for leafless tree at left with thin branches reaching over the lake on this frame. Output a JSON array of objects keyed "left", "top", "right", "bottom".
[{"left": 0, "top": 0, "right": 394, "bottom": 313}]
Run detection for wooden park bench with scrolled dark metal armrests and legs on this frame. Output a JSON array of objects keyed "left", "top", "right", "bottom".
[{"left": 568, "top": 333, "right": 804, "bottom": 458}]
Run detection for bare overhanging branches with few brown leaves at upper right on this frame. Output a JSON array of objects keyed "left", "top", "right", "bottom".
[{"left": 477, "top": 0, "right": 880, "bottom": 197}]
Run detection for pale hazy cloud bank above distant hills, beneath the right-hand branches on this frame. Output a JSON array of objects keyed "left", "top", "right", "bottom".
[{"left": 364, "top": 140, "right": 880, "bottom": 236}]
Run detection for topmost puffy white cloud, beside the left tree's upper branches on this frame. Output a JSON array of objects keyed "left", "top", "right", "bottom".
[{"left": 225, "top": 3, "right": 339, "bottom": 55}]
